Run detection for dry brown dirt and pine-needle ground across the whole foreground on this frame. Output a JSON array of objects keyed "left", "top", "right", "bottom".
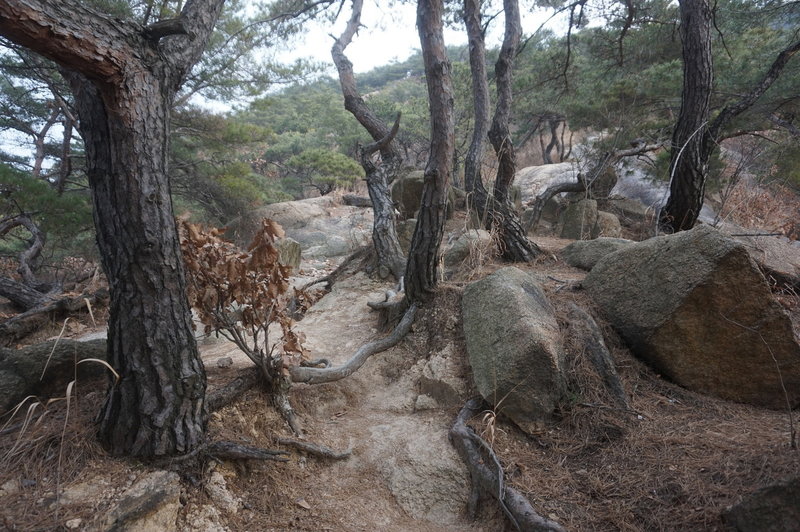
[{"left": 0, "top": 238, "right": 800, "bottom": 531}]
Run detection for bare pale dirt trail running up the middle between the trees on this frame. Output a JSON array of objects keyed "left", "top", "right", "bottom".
[{"left": 201, "top": 273, "right": 502, "bottom": 531}]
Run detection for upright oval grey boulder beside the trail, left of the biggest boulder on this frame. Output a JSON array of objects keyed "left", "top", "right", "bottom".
[{"left": 461, "top": 267, "right": 564, "bottom": 433}]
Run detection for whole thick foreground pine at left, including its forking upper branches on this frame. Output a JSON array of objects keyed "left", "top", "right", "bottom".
[{"left": 0, "top": 0, "right": 224, "bottom": 456}]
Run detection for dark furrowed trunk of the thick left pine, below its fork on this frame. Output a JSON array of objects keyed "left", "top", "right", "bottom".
[{"left": 70, "top": 73, "right": 206, "bottom": 455}]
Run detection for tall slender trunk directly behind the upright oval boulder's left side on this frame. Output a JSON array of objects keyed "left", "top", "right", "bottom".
[{"left": 405, "top": 0, "right": 455, "bottom": 303}]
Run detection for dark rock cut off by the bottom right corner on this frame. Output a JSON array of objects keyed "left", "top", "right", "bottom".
[{"left": 722, "top": 478, "right": 800, "bottom": 532}]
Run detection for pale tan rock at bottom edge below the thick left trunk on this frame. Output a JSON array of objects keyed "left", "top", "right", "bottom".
[{"left": 104, "top": 471, "right": 181, "bottom": 532}]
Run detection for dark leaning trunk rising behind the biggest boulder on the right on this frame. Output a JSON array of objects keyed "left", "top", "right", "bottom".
[{"left": 660, "top": 0, "right": 714, "bottom": 232}]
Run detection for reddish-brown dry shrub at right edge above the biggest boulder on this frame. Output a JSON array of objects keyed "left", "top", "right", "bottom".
[{"left": 720, "top": 179, "right": 800, "bottom": 240}]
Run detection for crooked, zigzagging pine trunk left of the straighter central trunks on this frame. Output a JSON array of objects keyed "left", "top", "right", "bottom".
[{"left": 331, "top": 0, "right": 406, "bottom": 281}]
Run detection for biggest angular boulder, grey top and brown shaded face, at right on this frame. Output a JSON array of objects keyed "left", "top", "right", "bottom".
[{"left": 583, "top": 226, "right": 800, "bottom": 408}]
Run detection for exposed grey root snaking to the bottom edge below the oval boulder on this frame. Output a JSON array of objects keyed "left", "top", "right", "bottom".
[{"left": 450, "top": 398, "right": 564, "bottom": 532}]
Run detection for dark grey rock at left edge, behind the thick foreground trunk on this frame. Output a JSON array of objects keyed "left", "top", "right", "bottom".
[{"left": 0, "top": 340, "right": 108, "bottom": 413}]
